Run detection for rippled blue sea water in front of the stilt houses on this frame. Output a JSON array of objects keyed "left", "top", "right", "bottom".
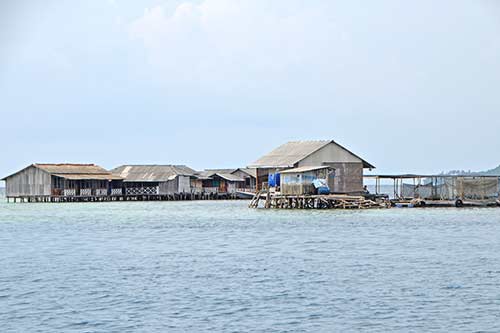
[{"left": 0, "top": 196, "right": 500, "bottom": 332}]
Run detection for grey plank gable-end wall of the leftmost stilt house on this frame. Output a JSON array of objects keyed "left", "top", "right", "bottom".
[{"left": 5, "top": 166, "right": 51, "bottom": 197}]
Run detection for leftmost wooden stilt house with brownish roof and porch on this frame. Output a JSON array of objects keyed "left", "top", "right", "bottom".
[{"left": 2, "top": 163, "right": 122, "bottom": 200}]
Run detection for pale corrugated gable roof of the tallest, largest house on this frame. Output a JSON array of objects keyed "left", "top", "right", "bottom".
[{"left": 249, "top": 140, "right": 375, "bottom": 168}]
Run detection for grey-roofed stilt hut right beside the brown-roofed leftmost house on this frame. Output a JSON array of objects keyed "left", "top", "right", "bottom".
[{"left": 111, "top": 165, "right": 196, "bottom": 196}]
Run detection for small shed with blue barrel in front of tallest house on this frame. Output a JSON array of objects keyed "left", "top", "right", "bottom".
[{"left": 281, "top": 166, "right": 335, "bottom": 195}]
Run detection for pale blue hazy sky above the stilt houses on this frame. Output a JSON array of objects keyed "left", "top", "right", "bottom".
[{"left": 0, "top": 0, "right": 500, "bottom": 176}]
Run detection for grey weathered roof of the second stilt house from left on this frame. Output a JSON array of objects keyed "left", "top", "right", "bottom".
[{"left": 111, "top": 165, "right": 196, "bottom": 182}]
